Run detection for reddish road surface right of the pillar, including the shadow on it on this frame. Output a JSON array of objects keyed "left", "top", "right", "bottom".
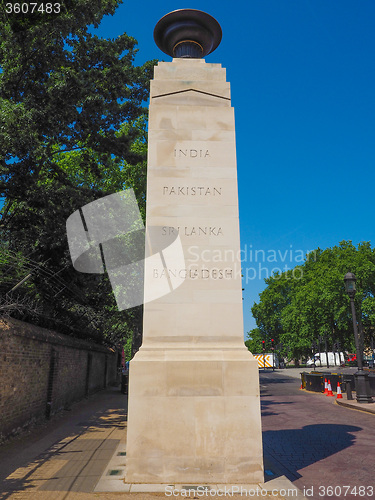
[{"left": 260, "top": 371, "right": 375, "bottom": 500}]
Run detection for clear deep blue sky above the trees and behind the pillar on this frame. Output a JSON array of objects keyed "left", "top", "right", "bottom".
[{"left": 92, "top": 0, "right": 375, "bottom": 336}]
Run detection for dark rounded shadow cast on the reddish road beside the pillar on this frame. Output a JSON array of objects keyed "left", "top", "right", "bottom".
[{"left": 263, "top": 424, "right": 362, "bottom": 481}]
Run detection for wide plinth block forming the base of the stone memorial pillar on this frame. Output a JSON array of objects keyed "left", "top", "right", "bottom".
[{"left": 126, "top": 347, "right": 264, "bottom": 484}]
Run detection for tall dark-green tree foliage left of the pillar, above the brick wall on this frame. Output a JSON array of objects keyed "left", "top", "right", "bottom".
[{"left": 0, "top": 0, "right": 155, "bottom": 348}]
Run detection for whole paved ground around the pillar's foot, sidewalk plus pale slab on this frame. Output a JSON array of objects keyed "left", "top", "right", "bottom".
[{"left": 0, "top": 388, "right": 303, "bottom": 500}]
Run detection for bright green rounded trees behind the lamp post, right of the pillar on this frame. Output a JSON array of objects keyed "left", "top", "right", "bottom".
[{"left": 249, "top": 241, "right": 375, "bottom": 359}]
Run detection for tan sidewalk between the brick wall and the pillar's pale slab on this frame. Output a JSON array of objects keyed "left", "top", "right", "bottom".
[{"left": 0, "top": 388, "right": 126, "bottom": 500}]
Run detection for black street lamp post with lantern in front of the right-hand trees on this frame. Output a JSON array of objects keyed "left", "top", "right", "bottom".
[{"left": 344, "top": 273, "right": 373, "bottom": 403}]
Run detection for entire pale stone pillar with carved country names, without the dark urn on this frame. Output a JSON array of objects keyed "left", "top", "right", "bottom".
[{"left": 126, "top": 59, "right": 263, "bottom": 484}]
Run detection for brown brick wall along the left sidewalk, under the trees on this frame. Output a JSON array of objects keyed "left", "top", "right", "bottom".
[{"left": 0, "top": 319, "right": 119, "bottom": 441}]
